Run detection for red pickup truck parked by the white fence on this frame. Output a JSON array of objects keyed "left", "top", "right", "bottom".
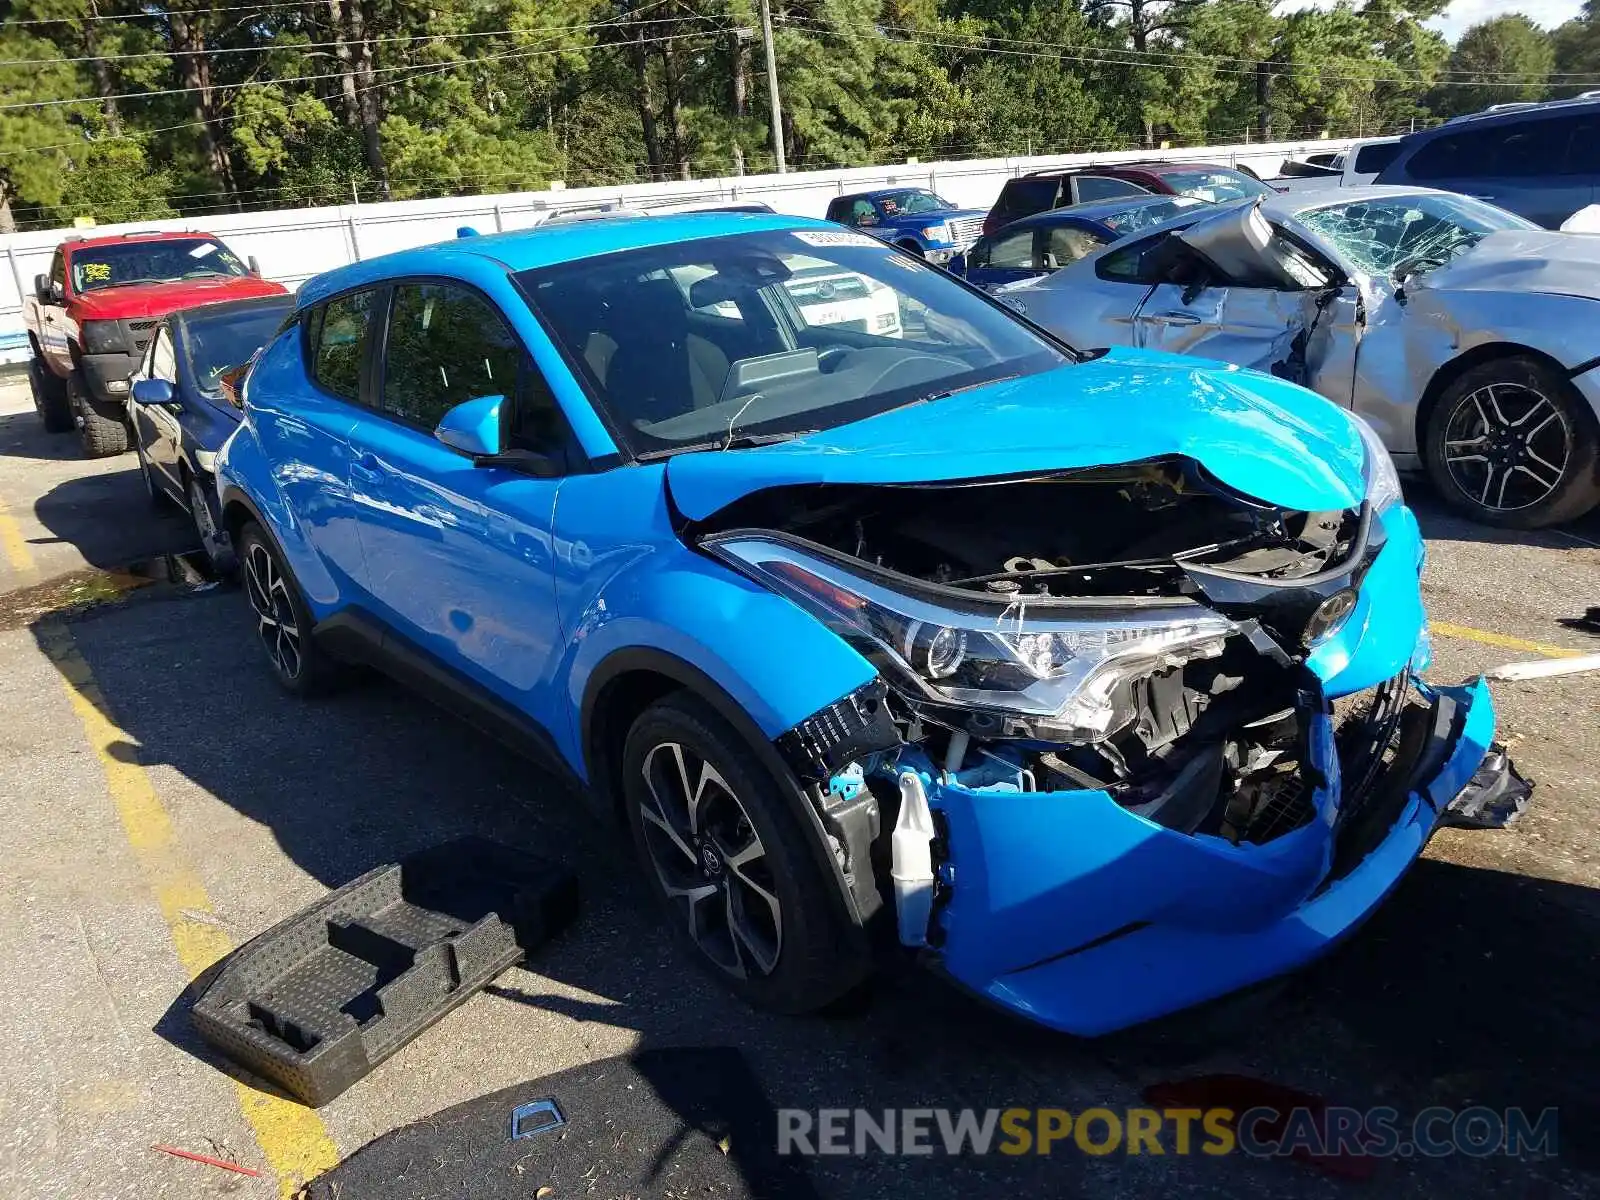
[{"left": 22, "top": 232, "right": 286, "bottom": 458}]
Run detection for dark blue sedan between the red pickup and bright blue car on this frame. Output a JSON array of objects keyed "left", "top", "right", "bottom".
[{"left": 126, "top": 294, "right": 294, "bottom": 571}]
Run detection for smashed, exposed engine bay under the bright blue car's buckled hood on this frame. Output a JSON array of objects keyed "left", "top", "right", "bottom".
[{"left": 696, "top": 459, "right": 1405, "bottom": 896}]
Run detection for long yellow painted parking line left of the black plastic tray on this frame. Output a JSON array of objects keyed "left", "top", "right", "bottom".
[{"left": 38, "top": 621, "right": 339, "bottom": 1200}]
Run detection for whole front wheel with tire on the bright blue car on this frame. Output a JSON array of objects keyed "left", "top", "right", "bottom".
[{"left": 622, "top": 691, "right": 867, "bottom": 1013}]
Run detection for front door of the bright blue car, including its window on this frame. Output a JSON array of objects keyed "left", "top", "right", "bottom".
[{"left": 350, "top": 280, "right": 562, "bottom": 707}]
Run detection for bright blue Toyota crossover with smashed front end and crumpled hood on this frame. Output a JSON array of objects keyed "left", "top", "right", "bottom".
[{"left": 219, "top": 213, "right": 1494, "bottom": 1034}]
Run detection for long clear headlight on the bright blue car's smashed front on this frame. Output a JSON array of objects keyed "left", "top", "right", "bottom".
[{"left": 706, "top": 534, "right": 1238, "bottom": 742}]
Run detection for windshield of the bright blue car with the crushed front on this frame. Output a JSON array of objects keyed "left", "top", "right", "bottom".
[{"left": 517, "top": 229, "right": 1072, "bottom": 456}]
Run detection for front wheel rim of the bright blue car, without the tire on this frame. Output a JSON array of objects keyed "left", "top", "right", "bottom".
[{"left": 638, "top": 742, "right": 782, "bottom": 979}]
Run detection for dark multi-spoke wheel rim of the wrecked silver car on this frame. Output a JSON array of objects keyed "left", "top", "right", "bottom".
[{"left": 1445, "top": 384, "right": 1573, "bottom": 512}]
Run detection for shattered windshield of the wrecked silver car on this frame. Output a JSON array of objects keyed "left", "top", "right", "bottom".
[{"left": 1299, "top": 192, "right": 1536, "bottom": 277}]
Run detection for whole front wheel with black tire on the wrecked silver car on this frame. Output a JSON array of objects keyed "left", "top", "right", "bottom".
[{"left": 1424, "top": 355, "right": 1600, "bottom": 530}]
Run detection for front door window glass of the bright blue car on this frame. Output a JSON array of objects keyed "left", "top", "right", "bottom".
[{"left": 381, "top": 283, "right": 522, "bottom": 429}]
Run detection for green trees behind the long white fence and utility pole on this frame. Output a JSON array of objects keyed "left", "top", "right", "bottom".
[{"left": 0, "top": 0, "right": 1600, "bottom": 229}]
